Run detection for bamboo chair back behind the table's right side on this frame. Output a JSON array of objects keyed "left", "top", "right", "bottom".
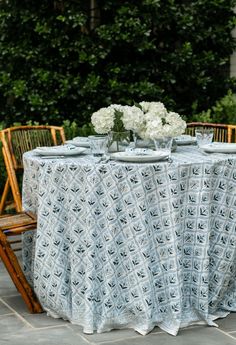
[{"left": 186, "top": 122, "right": 236, "bottom": 143}]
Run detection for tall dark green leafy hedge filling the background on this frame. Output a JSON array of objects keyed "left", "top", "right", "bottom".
[{"left": 0, "top": 0, "right": 236, "bottom": 127}]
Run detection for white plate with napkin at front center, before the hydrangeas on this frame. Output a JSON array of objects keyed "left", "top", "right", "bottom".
[{"left": 111, "top": 151, "right": 169, "bottom": 162}]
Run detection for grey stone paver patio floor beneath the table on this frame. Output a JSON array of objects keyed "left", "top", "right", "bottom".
[{"left": 0, "top": 261, "right": 236, "bottom": 345}]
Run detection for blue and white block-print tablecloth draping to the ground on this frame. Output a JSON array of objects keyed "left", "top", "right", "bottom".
[{"left": 23, "top": 146, "right": 236, "bottom": 335}]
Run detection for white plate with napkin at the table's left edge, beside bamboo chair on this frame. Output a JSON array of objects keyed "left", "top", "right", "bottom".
[{"left": 34, "top": 145, "right": 86, "bottom": 156}]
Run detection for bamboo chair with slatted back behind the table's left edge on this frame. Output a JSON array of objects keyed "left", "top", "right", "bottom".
[{"left": 0, "top": 125, "right": 65, "bottom": 214}]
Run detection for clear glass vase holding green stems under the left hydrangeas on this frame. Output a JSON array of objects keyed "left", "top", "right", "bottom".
[{"left": 108, "top": 131, "right": 130, "bottom": 152}]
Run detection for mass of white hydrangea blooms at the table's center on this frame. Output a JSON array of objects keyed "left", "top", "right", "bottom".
[{"left": 91, "top": 102, "right": 186, "bottom": 152}]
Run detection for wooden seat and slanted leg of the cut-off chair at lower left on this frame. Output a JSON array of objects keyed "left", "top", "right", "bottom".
[{"left": 0, "top": 212, "right": 43, "bottom": 313}]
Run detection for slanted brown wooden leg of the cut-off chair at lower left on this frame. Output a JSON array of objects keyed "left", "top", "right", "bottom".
[{"left": 0, "top": 234, "right": 43, "bottom": 313}]
